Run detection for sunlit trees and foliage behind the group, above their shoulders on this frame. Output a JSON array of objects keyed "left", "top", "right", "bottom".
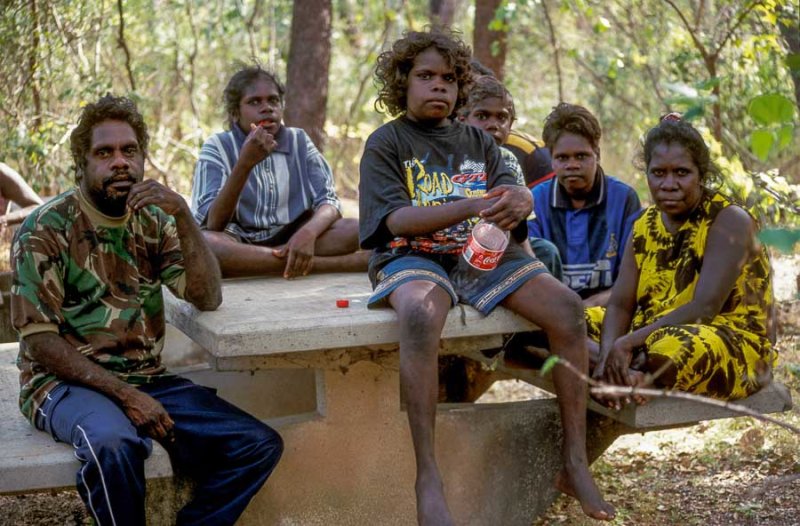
[{"left": 0, "top": 0, "right": 800, "bottom": 231}]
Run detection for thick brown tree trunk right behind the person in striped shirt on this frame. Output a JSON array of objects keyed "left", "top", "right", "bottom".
[{"left": 284, "top": 0, "right": 332, "bottom": 151}]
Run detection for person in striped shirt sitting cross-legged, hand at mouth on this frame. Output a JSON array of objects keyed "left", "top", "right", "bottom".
[{"left": 192, "top": 66, "right": 368, "bottom": 278}]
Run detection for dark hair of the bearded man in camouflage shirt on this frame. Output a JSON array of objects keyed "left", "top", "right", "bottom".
[{"left": 69, "top": 93, "right": 150, "bottom": 182}]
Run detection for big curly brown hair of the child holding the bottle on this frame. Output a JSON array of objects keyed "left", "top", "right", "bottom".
[{"left": 375, "top": 27, "right": 472, "bottom": 116}]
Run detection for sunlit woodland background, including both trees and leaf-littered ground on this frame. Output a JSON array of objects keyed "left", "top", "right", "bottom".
[{"left": 0, "top": 0, "right": 800, "bottom": 526}]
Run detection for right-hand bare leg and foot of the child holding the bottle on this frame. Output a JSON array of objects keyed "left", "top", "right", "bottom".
[{"left": 503, "top": 274, "right": 616, "bottom": 520}]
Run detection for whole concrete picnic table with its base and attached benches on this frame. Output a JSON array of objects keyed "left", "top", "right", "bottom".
[{"left": 0, "top": 274, "right": 790, "bottom": 525}]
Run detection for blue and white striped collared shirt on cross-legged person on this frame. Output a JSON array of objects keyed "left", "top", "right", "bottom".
[{"left": 191, "top": 125, "right": 341, "bottom": 243}]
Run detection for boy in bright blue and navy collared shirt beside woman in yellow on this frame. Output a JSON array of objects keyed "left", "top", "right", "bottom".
[{"left": 528, "top": 102, "right": 641, "bottom": 307}]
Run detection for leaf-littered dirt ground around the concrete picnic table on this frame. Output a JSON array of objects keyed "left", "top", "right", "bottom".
[{"left": 0, "top": 255, "right": 800, "bottom": 526}]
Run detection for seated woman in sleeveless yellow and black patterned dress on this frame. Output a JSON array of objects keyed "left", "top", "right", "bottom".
[{"left": 587, "top": 114, "right": 777, "bottom": 407}]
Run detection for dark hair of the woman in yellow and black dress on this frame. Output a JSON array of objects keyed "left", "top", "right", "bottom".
[{"left": 634, "top": 114, "right": 722, "bottom": 188}]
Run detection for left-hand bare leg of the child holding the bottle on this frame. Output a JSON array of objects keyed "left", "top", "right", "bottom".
[{"left": 389, "top": 281, "right": 453, "bottom": 526}]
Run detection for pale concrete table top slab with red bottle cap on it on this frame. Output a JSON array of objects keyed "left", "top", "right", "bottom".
[{"left": 165, "top": 273, "right": 536, "bottom": 368}]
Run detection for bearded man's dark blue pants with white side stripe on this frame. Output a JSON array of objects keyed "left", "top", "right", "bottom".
[{"left": 36, "top": 377, "right": 283, "bottom": 526}]
